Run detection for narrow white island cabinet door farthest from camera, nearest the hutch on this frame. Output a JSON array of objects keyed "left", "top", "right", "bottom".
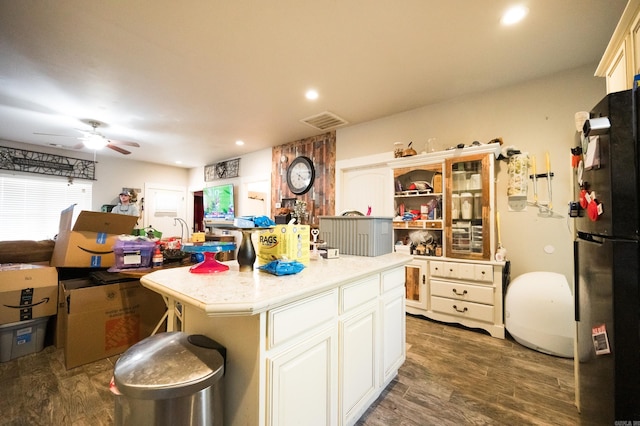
[{"left": 381, "top": 287, "right": 406, "bottom": 384}]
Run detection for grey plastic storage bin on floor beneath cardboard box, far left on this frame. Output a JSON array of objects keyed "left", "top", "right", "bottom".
[{"left": 0, "top": 317, "right": 49, "bottom": 362}]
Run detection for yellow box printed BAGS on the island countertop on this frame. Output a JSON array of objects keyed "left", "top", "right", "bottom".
[{"left": 256, "top": 225, "right": 311, "bottom": 265}]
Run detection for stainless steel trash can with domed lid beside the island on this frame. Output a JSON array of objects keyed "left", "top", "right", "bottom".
[{"left": 113, "top": 332, "right": 226, "bottom": 426}]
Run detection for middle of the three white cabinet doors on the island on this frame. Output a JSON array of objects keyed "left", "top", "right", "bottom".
[{"left": 340, "top": 301, "right": 378, "bottom": 424}]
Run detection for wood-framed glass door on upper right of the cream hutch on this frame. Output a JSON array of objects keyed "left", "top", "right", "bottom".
[{"left": 445, "top": 154, "right": 491, "bottom": 260}]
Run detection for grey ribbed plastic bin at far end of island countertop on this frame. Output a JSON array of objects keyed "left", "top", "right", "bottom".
[{"left": 319, "top": 216, "right": 393, "bottom": 256}]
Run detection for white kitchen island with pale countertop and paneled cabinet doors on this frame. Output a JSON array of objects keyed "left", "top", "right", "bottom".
[{"left": 141, "top": 254, "right": 412, "bottom": 426}]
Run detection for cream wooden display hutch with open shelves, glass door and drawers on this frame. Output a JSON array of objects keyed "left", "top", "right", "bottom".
[{"left": 389, "top": 143, "right": 505, "bottom": 338}]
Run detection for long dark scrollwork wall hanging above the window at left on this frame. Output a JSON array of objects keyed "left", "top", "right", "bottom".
[{"left": 0, "top": 146, "right": 96, "bottom": 180}]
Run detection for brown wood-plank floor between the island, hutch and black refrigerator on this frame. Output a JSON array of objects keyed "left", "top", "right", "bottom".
[{"left": 358, "top": 315, "right": 589, "bottom": 426}]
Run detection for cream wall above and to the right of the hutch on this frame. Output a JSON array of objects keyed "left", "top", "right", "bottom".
[{"left": 336, "top": 64, "right": 605, "bottom": 284}]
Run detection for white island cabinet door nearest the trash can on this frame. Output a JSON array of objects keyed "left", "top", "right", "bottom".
[{"left": 267, "top": 325, "right": 338, "bottom": 426}]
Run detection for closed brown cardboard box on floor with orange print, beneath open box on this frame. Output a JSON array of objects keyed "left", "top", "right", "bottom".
[{"left": 57, "top": 279, "right": 166, "bottom": 369}]
